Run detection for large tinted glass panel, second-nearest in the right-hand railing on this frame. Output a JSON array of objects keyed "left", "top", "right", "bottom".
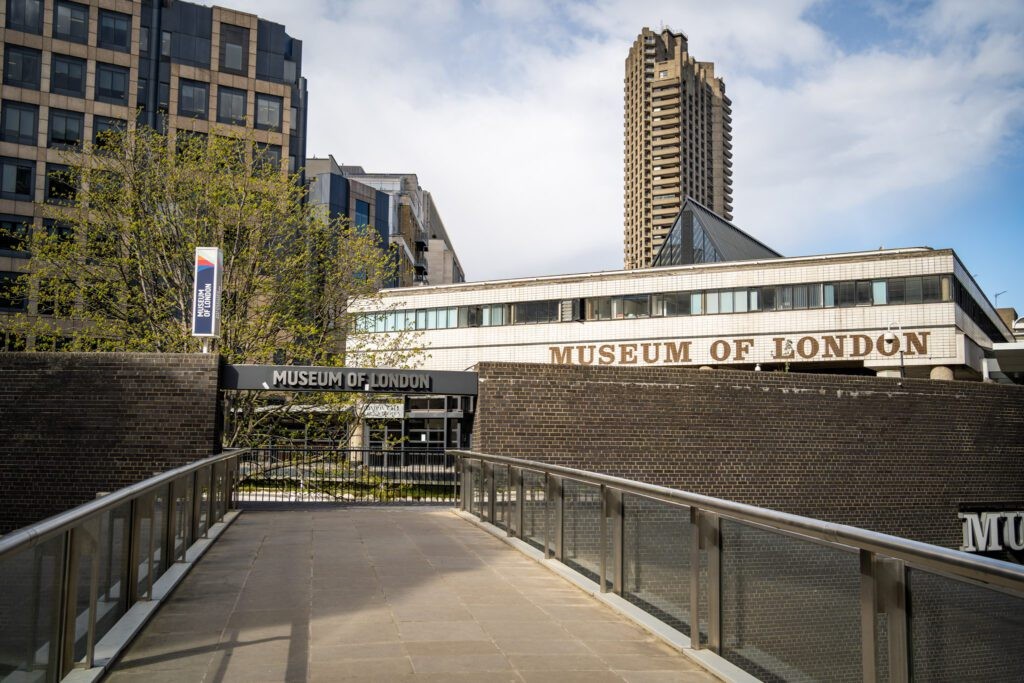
[{"left": 721, "top": 519, "right": 862, "bottom": 683}]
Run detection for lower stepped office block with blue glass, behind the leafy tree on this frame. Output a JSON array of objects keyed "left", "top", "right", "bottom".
[{"left": 306, "top": 156, "right": 465, "bottom": 287}]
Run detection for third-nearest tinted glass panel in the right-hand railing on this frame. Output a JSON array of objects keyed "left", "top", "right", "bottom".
[{"left": 623, "top": 494, "right": 692, "bottom": 635}]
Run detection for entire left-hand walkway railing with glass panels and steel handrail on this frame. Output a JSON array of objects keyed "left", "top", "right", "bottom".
[{"left": 0, "top": 451, "right": 245, "bottom": 681}]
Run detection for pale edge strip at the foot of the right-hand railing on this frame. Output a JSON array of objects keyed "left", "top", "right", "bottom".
[{"left": 452, "top": 508, "right": 760, "bottom": 683}]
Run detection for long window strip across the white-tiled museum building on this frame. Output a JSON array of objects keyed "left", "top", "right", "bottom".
[{"left": 356, "top": 275, "right": 952, "bottom": 332}]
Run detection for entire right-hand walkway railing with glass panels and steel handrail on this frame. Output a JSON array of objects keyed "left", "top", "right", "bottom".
[{"left": 453, "top": 452, "right": 1024, "bottom": 682}]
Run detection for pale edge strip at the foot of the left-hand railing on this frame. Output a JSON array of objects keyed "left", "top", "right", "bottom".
[{"left": 60, "top": 510, "right": 242, "bottom": 683}]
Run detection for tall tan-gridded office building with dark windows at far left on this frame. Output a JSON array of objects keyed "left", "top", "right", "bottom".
[{"left": 0, "top": 0, "right": 306, "bottom": 347}]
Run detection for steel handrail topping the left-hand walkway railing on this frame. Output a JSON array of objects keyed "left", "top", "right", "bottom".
[{"left": 0, "top": 449, "right": 250, "bottom": 560}]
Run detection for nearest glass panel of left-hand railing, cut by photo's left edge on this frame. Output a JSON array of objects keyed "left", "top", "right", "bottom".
[{"left": 0, "top": 536, "right": 65, "bottom": 681}]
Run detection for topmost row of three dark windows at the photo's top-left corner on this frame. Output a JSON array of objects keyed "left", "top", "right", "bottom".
[{"left": 7, "top": 0, "right": 131, "bottom": 52}]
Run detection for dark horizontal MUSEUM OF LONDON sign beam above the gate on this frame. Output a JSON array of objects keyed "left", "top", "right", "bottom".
[{"left": 220, "top": 366, "right": 477, "bottom": 395}]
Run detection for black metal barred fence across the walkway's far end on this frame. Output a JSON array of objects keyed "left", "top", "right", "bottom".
[{"left": 238, "top": 445, "right": 458, "bottom": 504}]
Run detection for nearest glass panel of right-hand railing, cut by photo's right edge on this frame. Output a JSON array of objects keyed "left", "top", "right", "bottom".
[{"left": 907, "top": 568, "right": 1024, "bottom": 683}]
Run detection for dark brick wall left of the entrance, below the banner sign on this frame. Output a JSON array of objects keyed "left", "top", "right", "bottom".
[{"left": 0, "top": 353, "right": 219, "bottom": 532}]
